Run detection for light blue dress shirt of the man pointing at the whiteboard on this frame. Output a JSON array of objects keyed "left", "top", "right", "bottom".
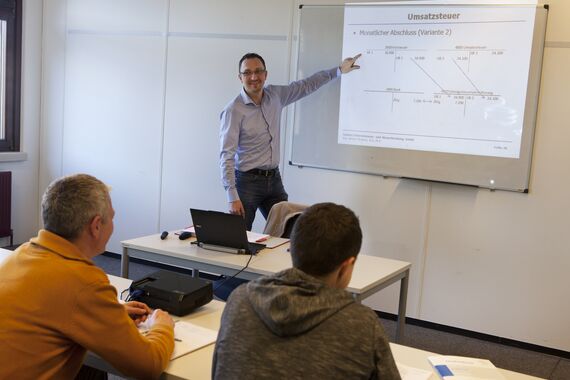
[{"left": 220, "top": 67, "right": 340, "bottom": 202}]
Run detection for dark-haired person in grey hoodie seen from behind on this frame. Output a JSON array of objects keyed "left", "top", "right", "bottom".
[{"left": 212, "top": 203, "right": 400, "bottom": 380}]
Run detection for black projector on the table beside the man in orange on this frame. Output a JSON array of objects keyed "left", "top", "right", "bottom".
[{"left": 129, "top": 270, "right": 214, "bottom": 316}]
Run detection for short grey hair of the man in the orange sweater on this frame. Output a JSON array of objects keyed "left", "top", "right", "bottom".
[{"left": 42, "top": 174, "right": 111, "bottom": 240}]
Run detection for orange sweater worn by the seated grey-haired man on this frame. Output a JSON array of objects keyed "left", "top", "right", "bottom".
[{"left": 0, "top": 230, "right": 174, "bottom": 379}]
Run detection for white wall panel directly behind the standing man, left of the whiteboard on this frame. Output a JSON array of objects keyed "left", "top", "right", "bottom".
[{"left": 160, "top": 0, "right": 292, "bottom": 233}]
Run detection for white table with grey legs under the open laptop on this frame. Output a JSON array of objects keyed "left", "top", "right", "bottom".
[{"left": 121, "top": 233, "right": 411, "bottom": 342}]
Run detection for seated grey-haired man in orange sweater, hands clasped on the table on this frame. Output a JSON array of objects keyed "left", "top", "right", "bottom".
[{"left": 0, "top": 174, "right": 174, "bottom": 379}]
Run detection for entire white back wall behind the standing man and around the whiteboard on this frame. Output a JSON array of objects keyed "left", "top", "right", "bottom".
[{"left": 36, "top": 0, "right": 570, "bottom": 351}]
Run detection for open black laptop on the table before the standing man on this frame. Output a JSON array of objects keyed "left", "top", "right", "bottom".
[{"left": 190, "top": 208, "right": 265, "bottom": 255}]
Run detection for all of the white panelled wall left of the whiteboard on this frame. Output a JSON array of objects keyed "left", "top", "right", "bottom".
[{"left": 40, "top": 0, "right": 292, "bottom": 252}]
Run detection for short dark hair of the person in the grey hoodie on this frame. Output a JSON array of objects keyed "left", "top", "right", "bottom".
[{"left": 291, "top": 203, "right": 362, "bottom": 276}]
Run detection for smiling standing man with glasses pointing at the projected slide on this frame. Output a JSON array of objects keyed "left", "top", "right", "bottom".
[{"left": 220, "top": 53, "right": 360, "bottom": 230}]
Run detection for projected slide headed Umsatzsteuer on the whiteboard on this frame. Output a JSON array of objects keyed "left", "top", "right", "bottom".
[{"left": 338, "top": 5, "right": 536, "bottom": 158}]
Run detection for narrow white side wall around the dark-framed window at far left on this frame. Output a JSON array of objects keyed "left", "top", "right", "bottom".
[{"left": 0, "top": 0, "right": 42, "bottom": 246}]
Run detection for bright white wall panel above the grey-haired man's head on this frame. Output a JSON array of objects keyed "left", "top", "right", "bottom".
[{"left": 62, "top": 0, "right": 168, "bottom": 252}]
